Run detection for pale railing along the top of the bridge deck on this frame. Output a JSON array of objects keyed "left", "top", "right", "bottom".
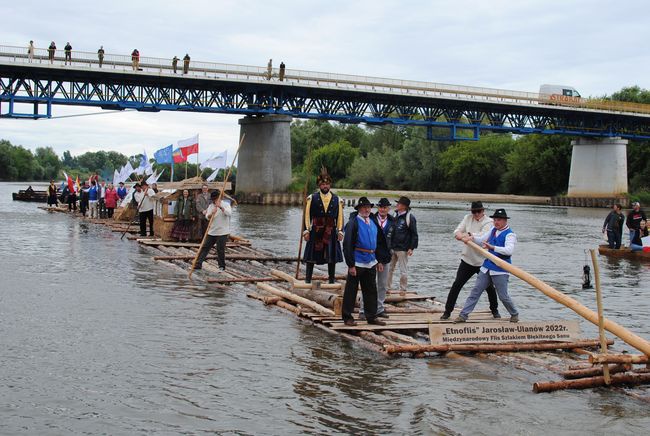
[{"left": 0, "top": 45, "right": 650, "bottom": 114}]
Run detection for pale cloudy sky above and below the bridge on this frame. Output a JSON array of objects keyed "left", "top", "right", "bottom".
[{"left": 0, "top": 0, "right": 650, "bottom": 160}]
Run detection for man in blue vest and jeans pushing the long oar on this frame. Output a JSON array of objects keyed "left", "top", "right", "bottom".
[{"left": 454, "top": 209, "right": 519, "bottom": 323}]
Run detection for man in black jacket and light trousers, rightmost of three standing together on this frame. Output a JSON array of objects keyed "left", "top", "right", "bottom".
[{"left": 388, "top": 196, "right": 418, "bottom": 293}]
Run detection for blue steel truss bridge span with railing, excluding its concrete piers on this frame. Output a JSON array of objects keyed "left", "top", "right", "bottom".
[{"left": 0, "top": 46, "right": 650, "bottom": 140}]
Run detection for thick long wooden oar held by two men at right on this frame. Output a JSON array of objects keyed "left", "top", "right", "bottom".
[{"left": 466, "top": 241, "right": 650, "bottom": 356}]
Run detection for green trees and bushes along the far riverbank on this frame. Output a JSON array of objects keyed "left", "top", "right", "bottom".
[{"left": 0, "top": 86, "right": 650, "bottom": 203}]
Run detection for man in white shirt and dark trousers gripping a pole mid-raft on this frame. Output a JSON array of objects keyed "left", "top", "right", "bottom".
[{"left": 194, "top": 190, "right": 232, "bottom": 271}]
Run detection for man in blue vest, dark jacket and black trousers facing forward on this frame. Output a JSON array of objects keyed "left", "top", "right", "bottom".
[{"left": 342, "top": 197, "right": 389, "bottom": 326}]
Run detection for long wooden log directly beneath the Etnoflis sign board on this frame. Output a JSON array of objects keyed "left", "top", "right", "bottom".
[{"left": 384, "top": 338, "right": 614, "bottom": 353}]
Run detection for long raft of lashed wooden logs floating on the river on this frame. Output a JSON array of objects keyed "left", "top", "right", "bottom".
[{"left": 44, "top": 209, "right": 650, "bottom": 393}]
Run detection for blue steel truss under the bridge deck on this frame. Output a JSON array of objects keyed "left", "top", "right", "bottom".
[{"left": 0, "top": 64, "right": 650, "bottom": 140}]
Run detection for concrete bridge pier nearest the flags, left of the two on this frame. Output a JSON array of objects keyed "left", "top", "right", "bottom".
[{"left": 236, "top": 115, "right": 292, "bottom": 194}]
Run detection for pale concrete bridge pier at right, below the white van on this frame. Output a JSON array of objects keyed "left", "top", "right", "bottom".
[{"left": 567, "top": 138, "right": 627, "bottom": 198}]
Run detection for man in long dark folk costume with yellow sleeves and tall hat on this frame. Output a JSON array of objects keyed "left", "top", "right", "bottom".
[{"left": 303, "top": 167, "right": 343, "bottom": 283}]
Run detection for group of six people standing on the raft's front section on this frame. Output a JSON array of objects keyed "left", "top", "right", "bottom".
[{"left": 303, "top": 168, "right": 519, "bottom": 326}]
